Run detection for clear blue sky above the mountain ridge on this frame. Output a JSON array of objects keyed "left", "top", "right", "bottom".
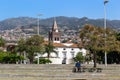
[{"left": 0, "top": 0, "right": 120, "bottom": 21}]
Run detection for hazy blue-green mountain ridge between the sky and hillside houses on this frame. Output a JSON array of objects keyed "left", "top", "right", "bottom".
[{"left": 0, "top": 16, "right": 120, "bottom": 30}]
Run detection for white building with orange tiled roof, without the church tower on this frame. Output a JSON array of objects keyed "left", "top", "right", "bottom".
[{"left": 42, "top": 43, "right": 86, "bottom": 64}]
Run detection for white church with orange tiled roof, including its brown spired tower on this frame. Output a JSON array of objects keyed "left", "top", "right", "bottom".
[{"left": 38, "top": 20, "right": 86, "bottom": 64}]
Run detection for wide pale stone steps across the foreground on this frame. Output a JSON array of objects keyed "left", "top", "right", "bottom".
[{"left": 0, "top": 64, "right": 120, "bottom": 80}]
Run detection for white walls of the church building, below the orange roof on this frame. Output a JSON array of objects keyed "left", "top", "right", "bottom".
[{"left": 42, "top": 47, "right": 86, "bottom": 64}]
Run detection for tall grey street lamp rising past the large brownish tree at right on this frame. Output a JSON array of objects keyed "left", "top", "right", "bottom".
[{"left": 104, "top": 0, "right": 108, "bottom": 66}]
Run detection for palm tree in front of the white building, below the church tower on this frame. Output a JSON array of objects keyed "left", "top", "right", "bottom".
[{"left": 44, "top": 42, "right": 57, "bottom": 59}]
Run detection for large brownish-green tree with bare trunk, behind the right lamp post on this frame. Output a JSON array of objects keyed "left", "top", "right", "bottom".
[{"left": 80, "top": 25, "right": 119, "bottom": 67}]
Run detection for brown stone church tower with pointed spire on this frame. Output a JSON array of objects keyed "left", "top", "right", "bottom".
[{"left": 49, "top": 20, "right": 61, "bottom": 43}]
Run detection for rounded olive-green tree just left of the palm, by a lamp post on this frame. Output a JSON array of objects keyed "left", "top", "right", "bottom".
[{"left": 25, "top": 35, "right": 44, "bottom": 63}]
